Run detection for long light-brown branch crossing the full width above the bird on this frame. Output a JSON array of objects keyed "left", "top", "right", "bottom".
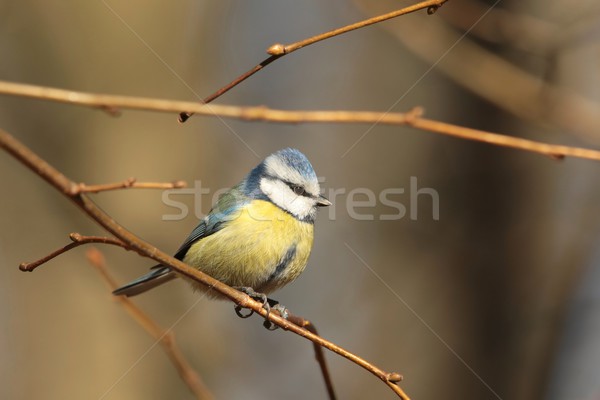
[{"left": 0, "top": 79, "right": 600, "bottom": 162}]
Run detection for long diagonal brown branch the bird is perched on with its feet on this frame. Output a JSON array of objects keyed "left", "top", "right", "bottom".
[{"left": 0, "top": 129, "right": 409, "bottom": 400}]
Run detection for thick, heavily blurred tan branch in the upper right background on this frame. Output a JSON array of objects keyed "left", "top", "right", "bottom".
[{"left": 357, "top": 1, "right": 600, "bottom": 142}]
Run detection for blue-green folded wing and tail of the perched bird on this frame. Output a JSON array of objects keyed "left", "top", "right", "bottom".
[{"left": 113, "top": 185, "right": 250, "bottom": 296}]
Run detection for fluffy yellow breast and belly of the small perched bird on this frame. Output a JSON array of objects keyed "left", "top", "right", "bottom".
[{"left": 183, "top": 200, "right": 313, "bottom": 293}]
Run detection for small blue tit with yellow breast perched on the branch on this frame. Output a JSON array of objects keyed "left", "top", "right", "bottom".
[{"left": 113, "top": 148, "right": 331, "bottom": 298}]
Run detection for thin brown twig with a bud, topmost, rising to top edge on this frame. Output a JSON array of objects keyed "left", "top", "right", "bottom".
[{"left": 179, "top": 0, "right": 448, "bottom": 122}]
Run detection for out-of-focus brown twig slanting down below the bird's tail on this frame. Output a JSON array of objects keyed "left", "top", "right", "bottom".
[{"left": 85, "top": 247, "right": 213, "bottom": 400}]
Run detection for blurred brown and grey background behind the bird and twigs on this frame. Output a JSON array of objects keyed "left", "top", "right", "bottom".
[{"left": 0, "top": 0, "right": 600, "bottom": 399}]
